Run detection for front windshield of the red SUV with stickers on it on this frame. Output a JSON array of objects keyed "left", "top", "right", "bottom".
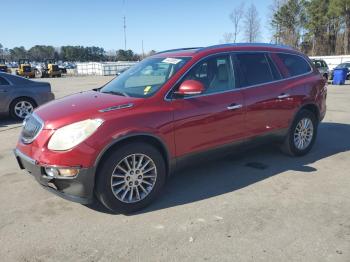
[{"left": 100, "top": 57, "right": 190, "bottom": 97}]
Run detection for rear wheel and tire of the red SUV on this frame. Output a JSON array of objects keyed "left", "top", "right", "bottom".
[{"left": 281, "top": 110, "right": 318, "bottom": 156}]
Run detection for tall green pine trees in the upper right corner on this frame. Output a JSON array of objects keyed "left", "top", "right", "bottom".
[{"left": 271, "top": 0, "right": 350, "bottom": 55}]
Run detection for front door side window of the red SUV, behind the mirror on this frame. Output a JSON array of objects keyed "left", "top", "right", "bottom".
[{"left": 179, "top": 55, "right": 234, "bottom": 94}]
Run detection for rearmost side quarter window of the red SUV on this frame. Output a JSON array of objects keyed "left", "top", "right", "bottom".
[{"left": 277, "top": 53, "right": 311, "bottom": 77}]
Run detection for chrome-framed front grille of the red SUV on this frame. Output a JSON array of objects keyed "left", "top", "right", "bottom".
[{"left": 21, "top": 114, "right": 44, "bottom": 144}]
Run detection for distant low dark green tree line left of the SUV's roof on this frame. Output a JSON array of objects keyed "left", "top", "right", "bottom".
[{"left": 0, "top": 44, "right": 155, "bottom": 62}]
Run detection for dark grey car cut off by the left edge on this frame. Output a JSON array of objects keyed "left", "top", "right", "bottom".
[{"left": 0, "top": 72, "right": 55, "bottom": 120}]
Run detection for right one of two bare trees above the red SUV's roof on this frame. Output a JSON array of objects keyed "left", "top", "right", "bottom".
[{"left": 244, "top": 4, "right": 260, "bottom": 43}]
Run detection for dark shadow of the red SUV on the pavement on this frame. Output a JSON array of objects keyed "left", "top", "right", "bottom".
[{"left": 88, "top": 123, "right": 350, "bottom": 215}]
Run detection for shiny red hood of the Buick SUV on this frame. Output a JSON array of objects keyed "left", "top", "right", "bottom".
[{"left": 35, "top": 91, "right": 144, "bottom": 129}]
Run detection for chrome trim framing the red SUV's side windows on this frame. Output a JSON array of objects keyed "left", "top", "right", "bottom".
[{"left": 164, "top": 50, "right": 314, "bottom": 101}]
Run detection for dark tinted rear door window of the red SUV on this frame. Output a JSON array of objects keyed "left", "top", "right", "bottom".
[{"left": 235, "top": 53, "right": 275, "bottom": 87}]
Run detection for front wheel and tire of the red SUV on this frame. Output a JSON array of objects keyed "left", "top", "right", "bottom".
[{"left": 95, "top": 142, "right": 166, "bottom": 214}]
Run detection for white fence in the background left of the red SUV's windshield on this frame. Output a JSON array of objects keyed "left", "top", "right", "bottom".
[{"left": 77, "top": 61, "right": 138, "bottom": 76}]
